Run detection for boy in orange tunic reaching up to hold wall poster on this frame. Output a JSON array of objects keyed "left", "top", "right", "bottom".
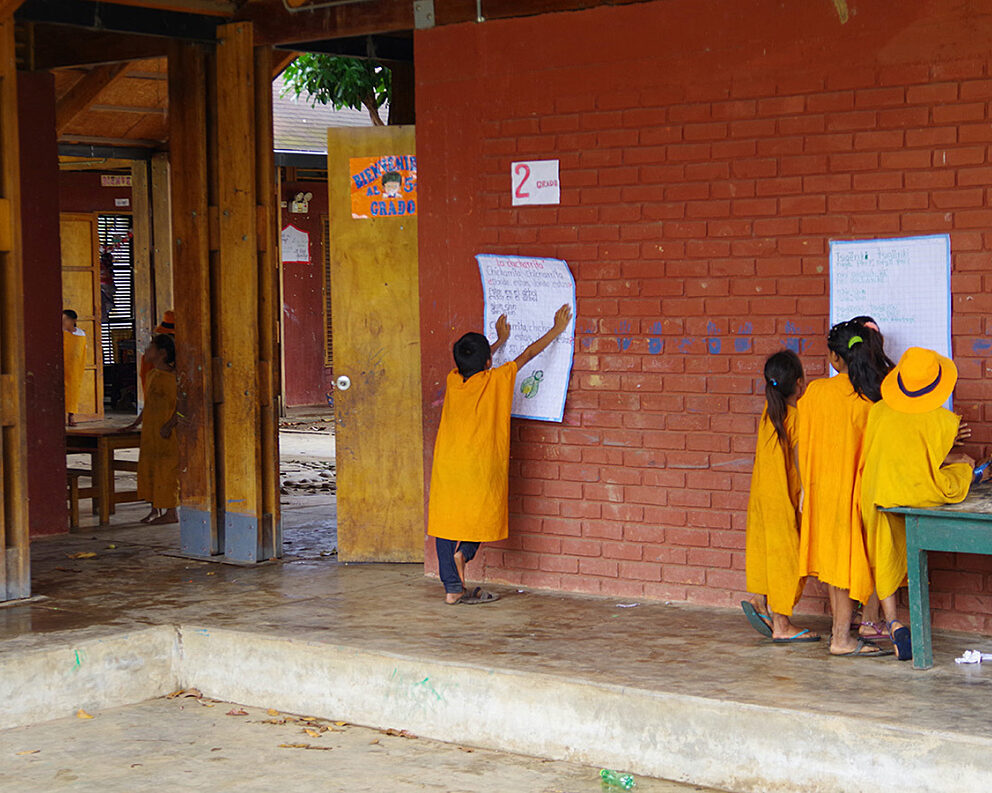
[{"left": 427, "top": 305, "right": 572, "bottom": 606}]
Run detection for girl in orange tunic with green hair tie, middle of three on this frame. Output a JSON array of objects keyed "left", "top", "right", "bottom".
[{"left": 799, "top": 322, "right": 891, "bottom": 656}]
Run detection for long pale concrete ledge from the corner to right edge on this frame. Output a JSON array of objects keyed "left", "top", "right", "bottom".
[{"left": 181, "top": 627, "right": 992, "bottom": 793}]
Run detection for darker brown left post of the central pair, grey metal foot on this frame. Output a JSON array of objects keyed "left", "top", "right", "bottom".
[{"left": 169, "top": 42, "right": 222, "bottom": 556}]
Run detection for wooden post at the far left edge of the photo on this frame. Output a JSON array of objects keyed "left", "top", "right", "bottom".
[{"left": 0, "top": 17, "right": 29, "bottom": 600}]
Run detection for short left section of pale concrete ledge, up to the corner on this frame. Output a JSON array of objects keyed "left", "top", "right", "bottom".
[{"left": 0, "top": 625, "right": 180, "bottom": 729}]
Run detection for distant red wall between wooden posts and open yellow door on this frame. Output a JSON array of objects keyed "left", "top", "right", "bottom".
[{"left": 280, "top": 176, "right": 329, "bottom": 407}]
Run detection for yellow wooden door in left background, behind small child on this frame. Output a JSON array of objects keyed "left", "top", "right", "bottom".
[{"left": 60, "top": 212, "right": 103, "bottom": 421}]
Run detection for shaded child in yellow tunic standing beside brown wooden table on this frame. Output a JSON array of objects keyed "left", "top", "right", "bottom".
[{"left": 131, "top": 333, "right": 179, "bottom": 524}]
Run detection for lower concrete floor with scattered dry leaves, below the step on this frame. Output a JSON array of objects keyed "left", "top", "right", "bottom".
[{"left": 0, "top": 698, "right": 704, "bottom": 793}]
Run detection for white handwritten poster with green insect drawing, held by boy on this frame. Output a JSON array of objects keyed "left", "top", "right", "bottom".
[{"left": 475, "top": 253, "right": 575, "bottom": 421}]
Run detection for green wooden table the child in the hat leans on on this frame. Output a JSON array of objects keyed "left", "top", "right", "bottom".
[{"left": 885, "top": 483, "right": 992, "bottom": 669}]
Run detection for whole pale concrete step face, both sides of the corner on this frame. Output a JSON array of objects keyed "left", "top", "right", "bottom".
[{"left": 0, "top": 624, "right": 992, "bottom": 793}]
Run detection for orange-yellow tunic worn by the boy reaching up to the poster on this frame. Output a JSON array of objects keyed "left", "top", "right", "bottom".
[{"left": 427, "top": 361, "right": 517, "bottom": 542}]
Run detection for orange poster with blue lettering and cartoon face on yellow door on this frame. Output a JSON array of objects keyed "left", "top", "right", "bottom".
[{"left": 348, "top": 154, "right": 417, "bottom": 219}]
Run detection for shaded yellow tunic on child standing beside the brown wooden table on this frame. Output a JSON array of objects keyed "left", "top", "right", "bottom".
[{"left": 138, "top": 369, "right": 179, "bottom": 509}]
